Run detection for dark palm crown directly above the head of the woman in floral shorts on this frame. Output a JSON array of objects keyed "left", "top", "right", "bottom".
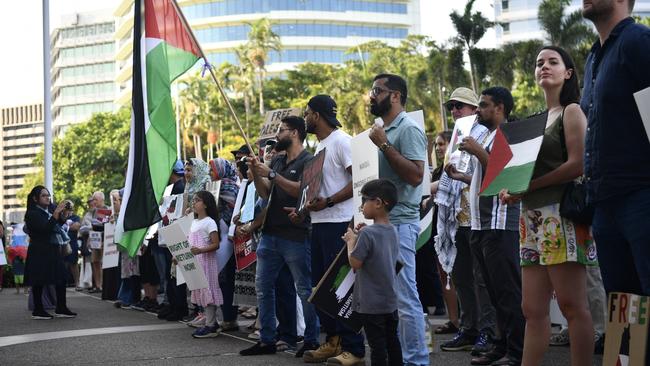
[{"left": 537, "top": 0, "right": 595, "bottom": 52}]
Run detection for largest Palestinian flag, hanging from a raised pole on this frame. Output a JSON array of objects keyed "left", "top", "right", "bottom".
[{"left": 115, "top": 0, "right": 201, "bottom": 256}]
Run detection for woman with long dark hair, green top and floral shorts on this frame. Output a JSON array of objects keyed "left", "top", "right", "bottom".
[{"left": 500, "top": 46, "right": 597, "bottom": 366}]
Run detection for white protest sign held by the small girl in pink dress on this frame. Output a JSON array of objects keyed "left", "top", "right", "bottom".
[{"left": 160, "top": 216, "right": 208, "bottom": 290}]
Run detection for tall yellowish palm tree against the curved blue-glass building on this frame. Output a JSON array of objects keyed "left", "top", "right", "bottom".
[{"left": 246, "top": 18, "right": 282, "bottom": 116}]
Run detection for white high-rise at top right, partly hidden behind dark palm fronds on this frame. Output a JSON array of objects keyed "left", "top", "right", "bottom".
[{"left": 494, "top": 0, "right": 650, "bottom": 45}]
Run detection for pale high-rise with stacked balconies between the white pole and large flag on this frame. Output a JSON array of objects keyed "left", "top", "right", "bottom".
[{"left": 51, "top": 9, "right": 117, "bottom": 133}]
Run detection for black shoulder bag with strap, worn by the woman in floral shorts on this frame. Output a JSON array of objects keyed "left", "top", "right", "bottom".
[{"left": 560, "top": 111, "right": 594, "bottom": 225}]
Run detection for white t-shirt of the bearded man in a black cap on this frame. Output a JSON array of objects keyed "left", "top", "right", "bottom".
[{"left": 310, "top": 129, "right": 354, "bottom": 224}]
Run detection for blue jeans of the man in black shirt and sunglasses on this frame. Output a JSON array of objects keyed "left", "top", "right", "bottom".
[{"left": 255, "top": 234, "right": 319, "bottom": 344}]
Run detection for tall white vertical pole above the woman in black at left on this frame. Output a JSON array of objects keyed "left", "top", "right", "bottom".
[{"left": 43, "top": 0, "right": 54, "bottom": 195}]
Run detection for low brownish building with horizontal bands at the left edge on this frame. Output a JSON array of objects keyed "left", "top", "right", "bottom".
[{"left": 0, "top": 104, "right": 43, "bottom": 223}]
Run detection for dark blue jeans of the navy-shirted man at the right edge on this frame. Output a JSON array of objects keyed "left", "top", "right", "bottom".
[{"left": 592, "top": 188, "right": 650, "bottom": 296}]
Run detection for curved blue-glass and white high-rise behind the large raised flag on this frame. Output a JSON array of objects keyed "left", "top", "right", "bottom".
[{"left": 114, "top": 0, "right": 420, "bottom": 105}]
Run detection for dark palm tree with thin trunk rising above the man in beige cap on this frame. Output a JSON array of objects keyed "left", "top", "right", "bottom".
[{"left": 449, "top": 0, "right": 496, "bottom": 92}]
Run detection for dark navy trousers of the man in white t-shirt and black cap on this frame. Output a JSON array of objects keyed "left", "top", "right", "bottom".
[{"left": 311, "top": 222, "right": 366, "bottom": 358}]
